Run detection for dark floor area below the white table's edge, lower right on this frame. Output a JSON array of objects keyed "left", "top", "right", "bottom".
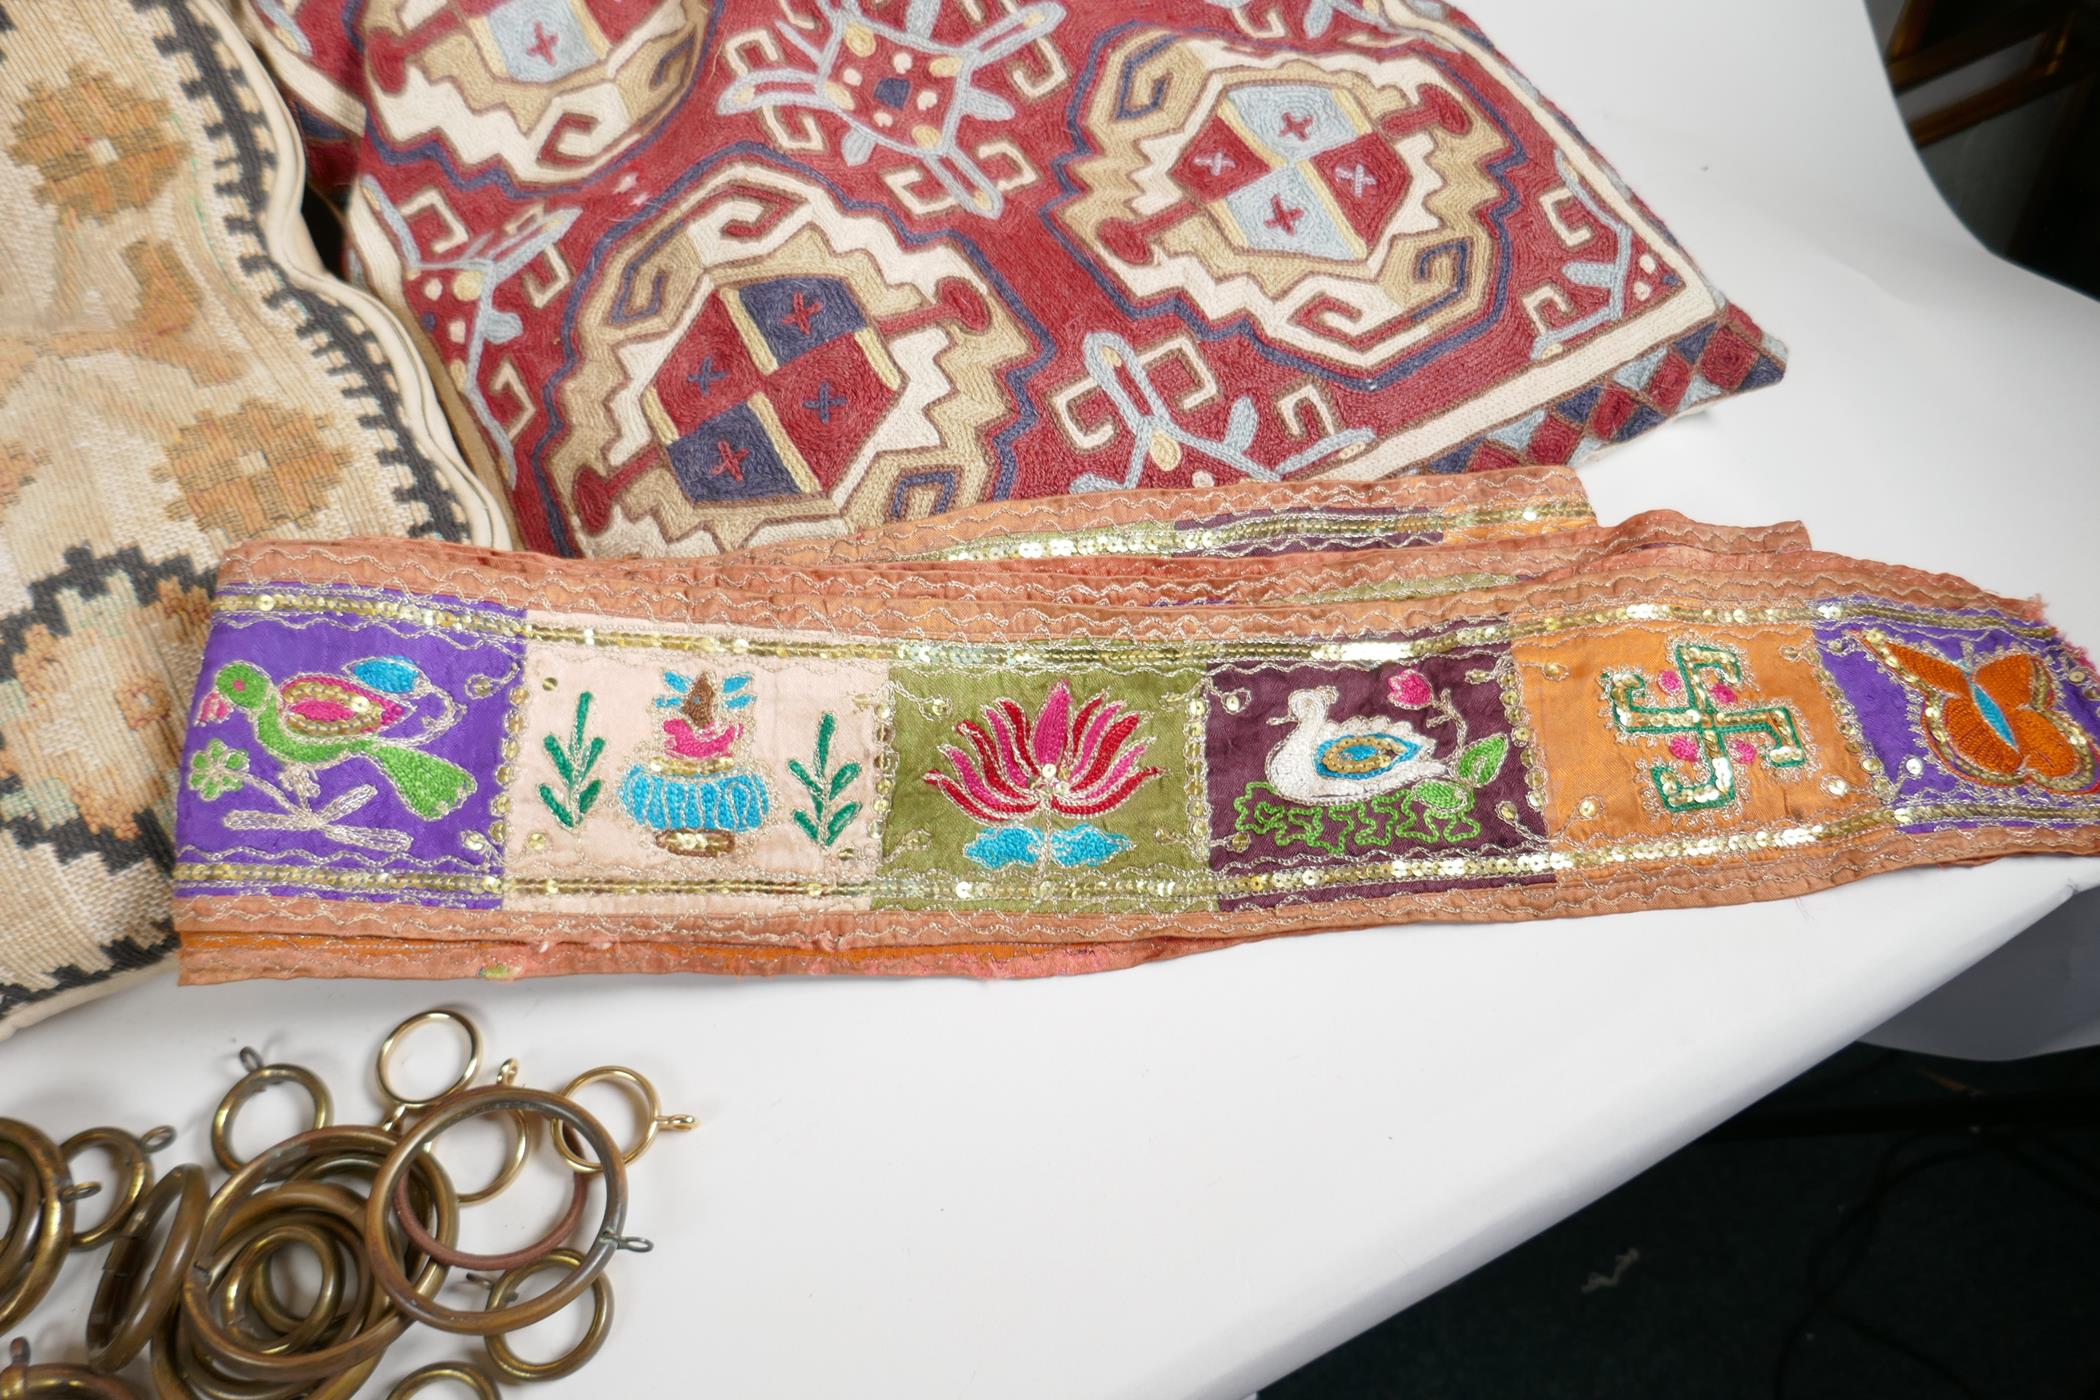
[{"left": 1260, "top": 1045, "right": 2100, "bottom": 1400}]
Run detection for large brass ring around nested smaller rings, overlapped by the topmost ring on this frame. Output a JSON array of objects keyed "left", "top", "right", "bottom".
[{"left": 181, "top": 1127, "right": 460, "bottom": 1381}]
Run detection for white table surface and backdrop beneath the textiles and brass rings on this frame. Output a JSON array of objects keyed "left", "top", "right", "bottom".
[{"left": 0, "top": 0, "right": 2100, "bottom": 1400}]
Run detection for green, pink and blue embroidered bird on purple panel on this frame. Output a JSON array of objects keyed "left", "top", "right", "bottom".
[{"left": 197, "top": 657, "right": 475, "bottom": 821}]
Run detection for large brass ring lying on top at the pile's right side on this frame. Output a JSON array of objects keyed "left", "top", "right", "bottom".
[{"left": 365, "top": 1085, "right": 634, "bottom": 1337}]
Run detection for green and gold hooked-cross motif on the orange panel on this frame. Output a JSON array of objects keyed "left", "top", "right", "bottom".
[{"left": 1604, "top": 642, "right": 1808, "bottom": 812}]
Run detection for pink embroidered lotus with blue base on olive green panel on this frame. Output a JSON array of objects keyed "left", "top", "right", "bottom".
[{"left": 926, "top": 680, "right": 1161, "bottom": 869}]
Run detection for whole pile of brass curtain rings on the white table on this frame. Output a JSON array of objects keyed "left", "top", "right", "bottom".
[{"left": 0, "top": 1010, "right": 695, "bottom": 1400}]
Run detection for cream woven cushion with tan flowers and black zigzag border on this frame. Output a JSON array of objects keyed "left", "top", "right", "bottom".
[{"left": 0, "top": 0, "right": 508, "bottom": 1035}]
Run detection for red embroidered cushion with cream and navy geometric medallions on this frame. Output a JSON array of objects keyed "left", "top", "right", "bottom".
[{"left": 234, "top": 0, "right": 1783, "bottom": 554}]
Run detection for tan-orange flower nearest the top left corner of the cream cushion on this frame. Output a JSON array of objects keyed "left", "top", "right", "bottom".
[{"left": 6, "top": 65, "right": 189, "bottom": 220}]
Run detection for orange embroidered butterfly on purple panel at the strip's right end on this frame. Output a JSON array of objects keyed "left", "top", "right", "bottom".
[{"left": 1856, "top": 630, "right": 2096, "bottom": 793}]
